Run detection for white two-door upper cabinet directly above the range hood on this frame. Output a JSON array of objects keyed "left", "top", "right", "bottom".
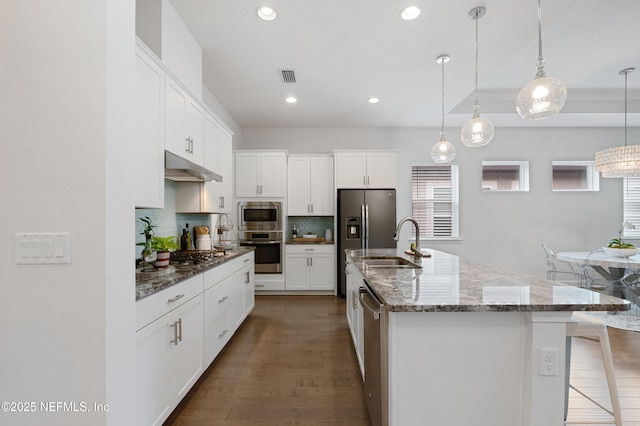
[{"left": 164, "top": 75, "right": 205, "bottom": 166}]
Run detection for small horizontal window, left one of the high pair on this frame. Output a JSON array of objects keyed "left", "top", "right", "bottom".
[{"left": 482, "top": 161, "right": 529, "bottom": 191}]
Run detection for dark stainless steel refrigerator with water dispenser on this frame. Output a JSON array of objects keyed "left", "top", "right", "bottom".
[{"left": 336, "top": 189, "right": 396, "bottom": 297}]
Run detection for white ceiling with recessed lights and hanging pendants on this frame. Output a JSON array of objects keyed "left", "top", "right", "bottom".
[{"left": 171, "top": 0, "right": 640, "bottom": 128}]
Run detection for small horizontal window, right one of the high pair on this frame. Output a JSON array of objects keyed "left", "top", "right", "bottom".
[{"left": 551, "top": 161, "right": 600, "bottom": 191}]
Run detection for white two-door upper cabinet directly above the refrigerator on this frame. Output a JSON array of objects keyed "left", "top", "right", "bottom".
[{"left": 335, "top": 151, "right": 398, "bottom": 189}]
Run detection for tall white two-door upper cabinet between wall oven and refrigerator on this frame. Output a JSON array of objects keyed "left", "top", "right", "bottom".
[{"left": 287, "top": 156, "right": 334, "bottom": 216}]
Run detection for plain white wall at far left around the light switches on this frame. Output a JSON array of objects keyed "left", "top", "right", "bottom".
[{"left": 0, "top": 0, "right": 135, "bottom": 425}]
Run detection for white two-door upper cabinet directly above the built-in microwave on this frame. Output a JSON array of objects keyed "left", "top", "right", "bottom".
[{"left": 234, "top": 151, "right": 287, "bottom": 198}]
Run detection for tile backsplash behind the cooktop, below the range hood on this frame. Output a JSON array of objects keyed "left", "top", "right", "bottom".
[{"left": 135, "top": 180, "right": 214, "bottom": 258}]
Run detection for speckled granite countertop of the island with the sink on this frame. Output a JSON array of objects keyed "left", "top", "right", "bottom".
[{"left": 347, "top": 249, "right": 630, "bottom": 312}]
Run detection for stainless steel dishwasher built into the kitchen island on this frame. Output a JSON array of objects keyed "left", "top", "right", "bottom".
[{"left": 360, "top": 281, "right": 387, "bottom": 426}]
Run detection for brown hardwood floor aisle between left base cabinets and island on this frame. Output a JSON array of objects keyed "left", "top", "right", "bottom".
[{"left": 165, "top": 296, "right": 369, "bottom": 426}]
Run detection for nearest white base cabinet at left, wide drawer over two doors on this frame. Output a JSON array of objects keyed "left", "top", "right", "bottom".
[{"left": 136, "top": 275, "right": 204, "bottom": 425}]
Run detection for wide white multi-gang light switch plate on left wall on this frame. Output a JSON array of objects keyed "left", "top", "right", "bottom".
[{"left": 14, "top": 232, "right": 71, "bottom": 265}]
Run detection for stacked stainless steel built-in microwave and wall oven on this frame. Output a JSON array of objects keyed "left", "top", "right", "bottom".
[{"left": 238, "top": 201, "right": 284, "bottom": 274}]
